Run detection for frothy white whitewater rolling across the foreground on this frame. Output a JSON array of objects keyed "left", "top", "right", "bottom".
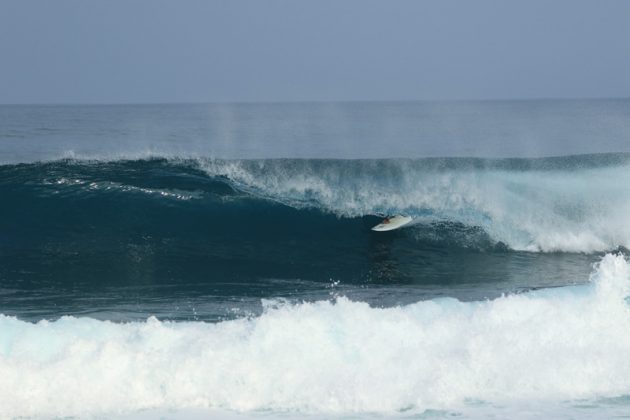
[{"left": 0, "top": 254, "right": 630, "bottom": 418}]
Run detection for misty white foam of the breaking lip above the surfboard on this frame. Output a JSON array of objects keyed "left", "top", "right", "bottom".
[{"left": 201, "top": 160, "right": 630, "bottom": 252}]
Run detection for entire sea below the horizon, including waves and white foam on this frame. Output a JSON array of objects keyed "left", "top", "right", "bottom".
[{"left": 0, "top": 99, "right": 630, "bottom": 419}]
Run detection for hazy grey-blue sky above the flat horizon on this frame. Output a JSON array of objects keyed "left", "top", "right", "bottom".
[{"left": 0, "top": 0, "right": 630, "bottom": 103}]
